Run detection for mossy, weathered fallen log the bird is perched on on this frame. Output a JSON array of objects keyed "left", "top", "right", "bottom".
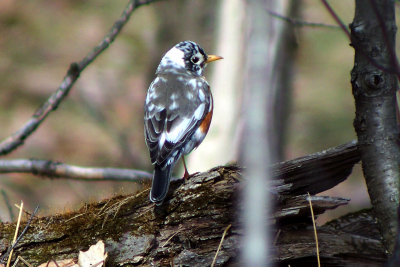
[{"left": 0, "top": 142, "right": 386, "bottom": 266}]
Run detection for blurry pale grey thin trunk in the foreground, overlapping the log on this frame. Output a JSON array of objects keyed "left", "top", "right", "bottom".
[{"left": 239, "top": 0, "right": 283, "bottom": 267}]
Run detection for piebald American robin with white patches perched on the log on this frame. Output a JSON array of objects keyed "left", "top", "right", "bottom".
[{"left": 144, "top": 41, "right": 222, "bottom": 205}]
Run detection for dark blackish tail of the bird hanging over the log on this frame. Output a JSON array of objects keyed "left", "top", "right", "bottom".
[{"left": 150, "top": 165, "right": 172, "bottom": 205}]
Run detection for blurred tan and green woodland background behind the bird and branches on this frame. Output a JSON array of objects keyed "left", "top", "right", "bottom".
[{"left": 0, "top": 0, "right": 384, "bottom": 223}]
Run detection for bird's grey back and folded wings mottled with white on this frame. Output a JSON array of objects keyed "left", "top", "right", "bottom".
[{"left": 144, "top": 75, "right": 211, "bottom": 169}]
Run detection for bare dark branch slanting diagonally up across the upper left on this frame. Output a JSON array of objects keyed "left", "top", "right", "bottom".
[{"left": 0, "top": 0, "right": 163, "bottom": 155}]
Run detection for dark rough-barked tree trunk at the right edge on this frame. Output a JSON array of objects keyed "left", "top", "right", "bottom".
[{"left": 350, "top": 0, "right": 400, "bottom": 253}]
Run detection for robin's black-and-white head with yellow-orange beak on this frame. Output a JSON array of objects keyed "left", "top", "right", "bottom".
[{"left": 157, "top": 41, "right": 222, "bottom": 76}]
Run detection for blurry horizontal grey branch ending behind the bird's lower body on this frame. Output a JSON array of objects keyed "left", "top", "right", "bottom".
[{"left": 0, "top": 159, "right": 152, "bottom": 182}]
